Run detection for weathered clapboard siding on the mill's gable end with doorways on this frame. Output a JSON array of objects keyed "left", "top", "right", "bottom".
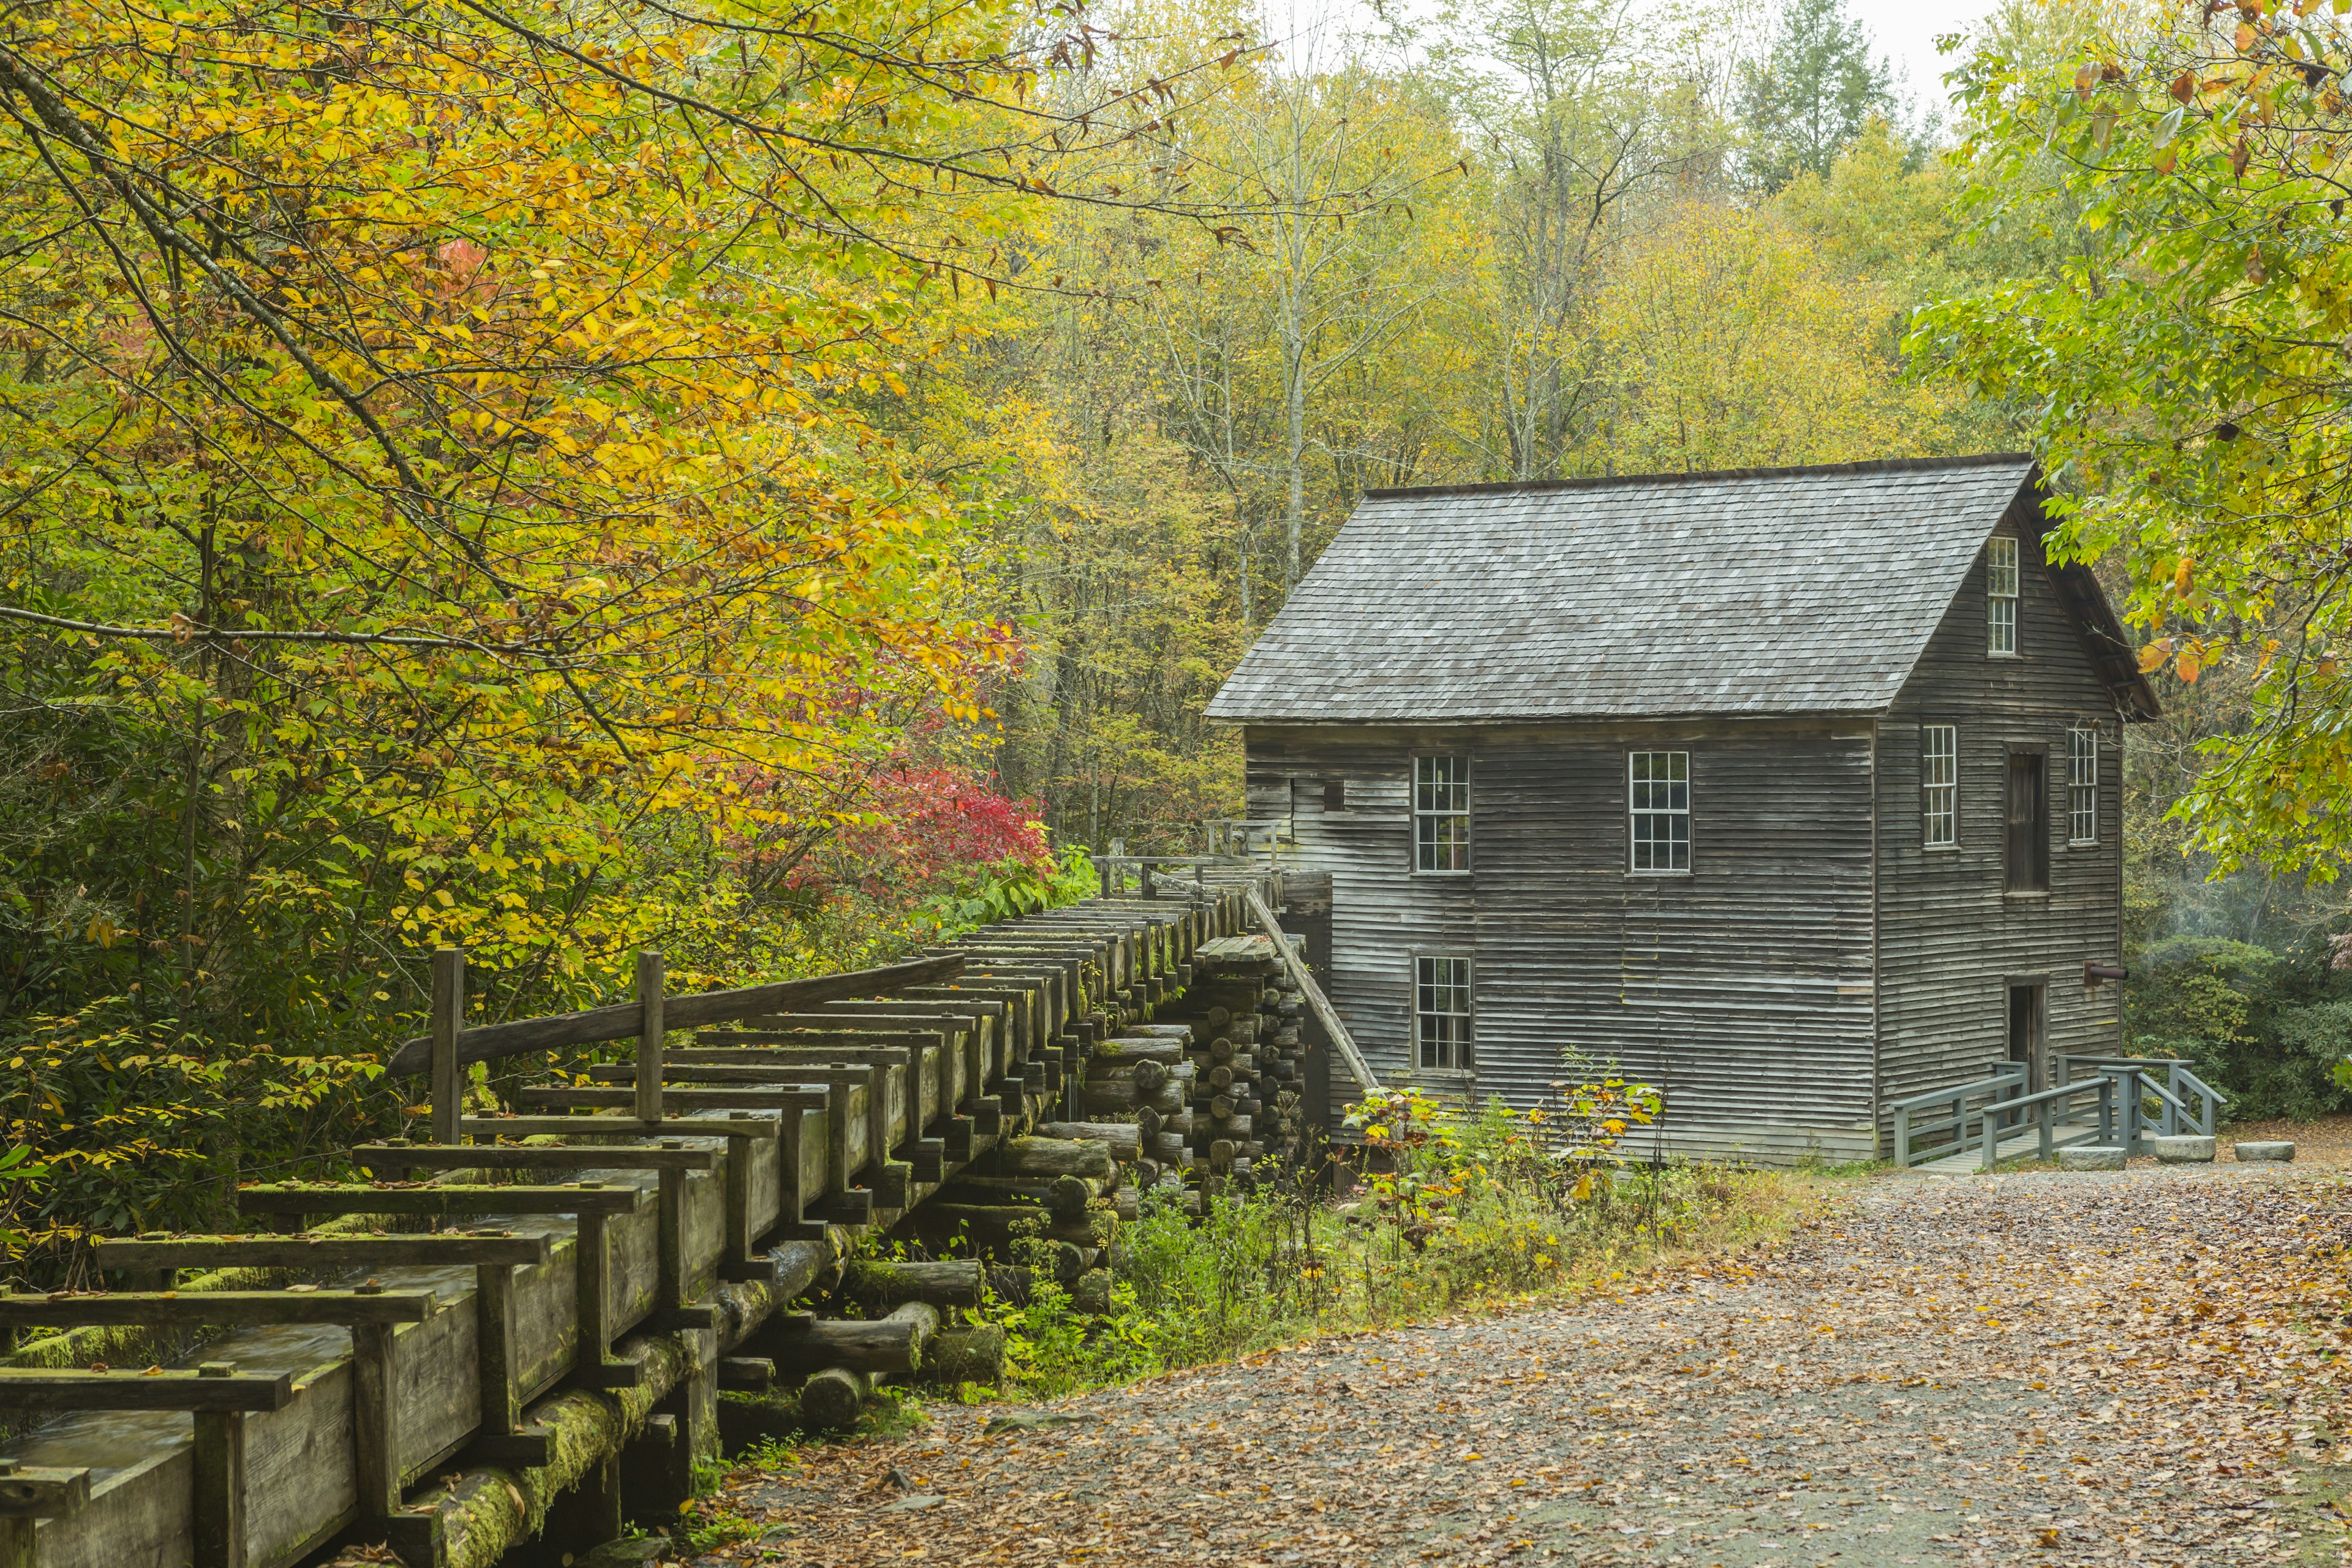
[{"left": 1879, "top": 494, "right": 2126, "bottom": 1128}]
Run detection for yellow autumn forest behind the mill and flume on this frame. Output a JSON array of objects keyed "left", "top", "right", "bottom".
[{"left": 0, "top": 0, "right": 2352, "bottom": 1239}]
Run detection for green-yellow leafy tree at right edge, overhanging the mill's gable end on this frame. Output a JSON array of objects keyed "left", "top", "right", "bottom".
[{"left": 1915, "top": 5, "right": 2352, "bottom": 881}]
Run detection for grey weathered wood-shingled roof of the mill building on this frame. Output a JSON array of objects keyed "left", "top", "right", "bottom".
[{"left": 1209, "top": 454, "right": 2154, "bottom": 724}]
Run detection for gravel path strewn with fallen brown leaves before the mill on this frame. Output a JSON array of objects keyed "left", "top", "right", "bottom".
[{"left": 706, "top": 1166, "right": 2352, "bottom": 1568}]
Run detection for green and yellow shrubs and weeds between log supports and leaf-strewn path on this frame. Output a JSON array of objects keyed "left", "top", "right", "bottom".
[{"left": 992, "top": 1082, "right": 1792, "bottom": 1396}]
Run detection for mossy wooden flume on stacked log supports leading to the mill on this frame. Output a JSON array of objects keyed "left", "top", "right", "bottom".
[{"left": 0, "top": 875, "right": 1305, "bottom": 1568}]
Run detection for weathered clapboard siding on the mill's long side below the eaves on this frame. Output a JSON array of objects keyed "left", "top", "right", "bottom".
[{"left": 1249, "top": 719, "right": 1872, "bottom": 1159}]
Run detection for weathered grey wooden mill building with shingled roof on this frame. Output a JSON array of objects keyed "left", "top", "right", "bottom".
[{"left": 1209, "top": 456, "right": 2157, "bottom": 1159}]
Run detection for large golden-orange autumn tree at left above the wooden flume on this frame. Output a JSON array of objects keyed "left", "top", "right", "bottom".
[{"left": 0, "top": 0, "right": 1242, "bottom": 1223}]
